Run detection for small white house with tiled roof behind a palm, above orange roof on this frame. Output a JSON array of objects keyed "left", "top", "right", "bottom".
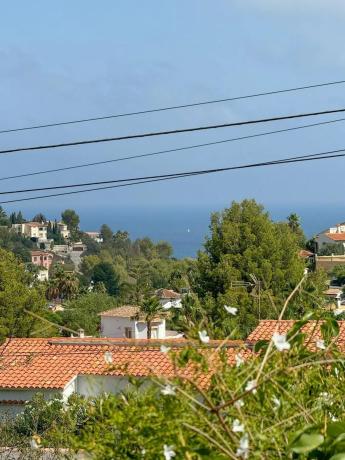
[{"left": 100, "top": 305, "right": 183, "bottom": 339}]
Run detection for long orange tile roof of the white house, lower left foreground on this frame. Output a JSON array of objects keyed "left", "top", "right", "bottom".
[{"left": 0, "top": 338, "right": 246, "bottom": 389}]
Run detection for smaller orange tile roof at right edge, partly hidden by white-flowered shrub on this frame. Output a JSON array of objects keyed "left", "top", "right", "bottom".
[{"left": 247, "top": 319, "right": 345, "bottom": 343}]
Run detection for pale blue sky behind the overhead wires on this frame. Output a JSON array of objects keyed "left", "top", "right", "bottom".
[{"left": 0, "top": 0, "right": 345, "bottom": 226}]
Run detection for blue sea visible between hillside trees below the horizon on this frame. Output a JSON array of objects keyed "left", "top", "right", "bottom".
[{"left": 76, "top": 204, "right": 345, "bottom": 258}]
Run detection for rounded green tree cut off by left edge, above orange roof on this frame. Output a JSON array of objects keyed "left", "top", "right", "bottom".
[{"left": 0, "top": 249, "right": 45, "bottom": 339}]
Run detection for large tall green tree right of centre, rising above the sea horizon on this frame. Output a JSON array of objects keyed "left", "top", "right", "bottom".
[{"left": 194, "top": 200, "right": 305, "bottom": 336}]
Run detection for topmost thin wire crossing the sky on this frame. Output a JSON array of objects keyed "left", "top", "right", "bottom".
[{"left": 0, "top": 80, "right": 345, "bottom": 134}]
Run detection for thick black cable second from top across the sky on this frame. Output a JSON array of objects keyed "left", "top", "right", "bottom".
[{"left": 0, "top": 108, "right": 345, "bottom": 154}]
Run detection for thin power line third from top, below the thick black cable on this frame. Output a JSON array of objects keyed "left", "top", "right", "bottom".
[{"left": 0, "top": 118, "right": 345, "bottom": 181}]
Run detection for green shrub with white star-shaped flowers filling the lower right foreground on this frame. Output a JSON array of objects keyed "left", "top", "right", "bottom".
[{"left": 59, "top": 314, "right": 345, "bottom": 460}]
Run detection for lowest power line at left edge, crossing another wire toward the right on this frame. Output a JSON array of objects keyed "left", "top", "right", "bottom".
[{"left": 0, "top": 149, "right": 345, "bottom": 204}]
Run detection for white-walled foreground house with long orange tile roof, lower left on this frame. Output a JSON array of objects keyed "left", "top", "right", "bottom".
[{"left": 0, "top": 338, "right": 245, "bottom": 417}]
